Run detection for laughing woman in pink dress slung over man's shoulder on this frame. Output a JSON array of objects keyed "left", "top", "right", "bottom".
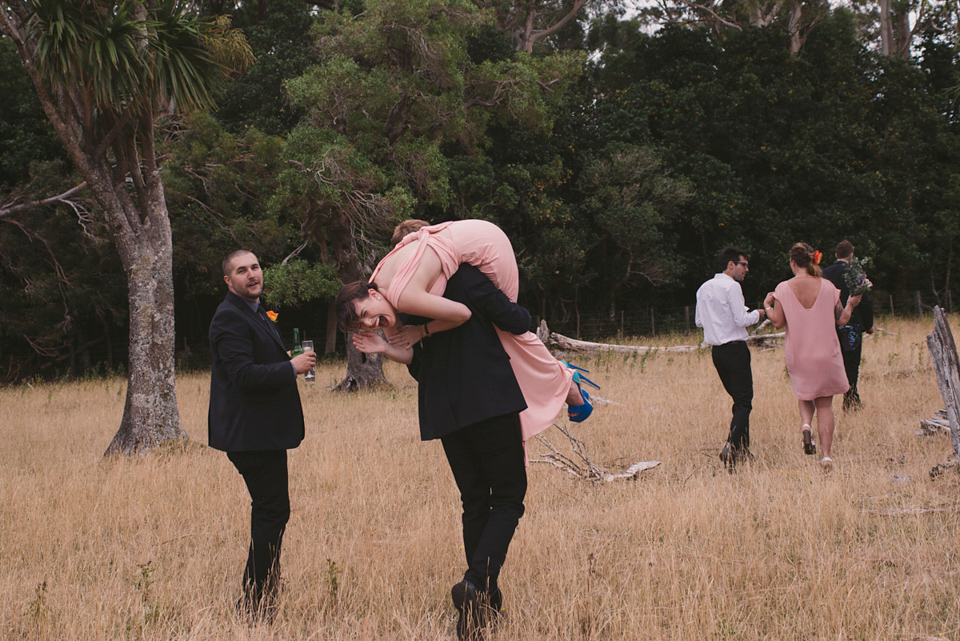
[{"left": 336, "top": 220, "right": 593, "bottom": 440}]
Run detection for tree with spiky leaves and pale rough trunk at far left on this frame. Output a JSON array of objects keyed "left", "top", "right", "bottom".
[{"left": 0, "top": 0, "right": 250, "bottom": 454}]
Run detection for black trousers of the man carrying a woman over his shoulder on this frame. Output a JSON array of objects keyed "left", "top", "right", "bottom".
[{"left": 440, "top": 414, "right": 527, "bottom": 592}]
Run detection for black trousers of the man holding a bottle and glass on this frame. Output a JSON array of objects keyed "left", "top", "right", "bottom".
[{"left": 227, "top": 450, "right": 290, "bottom": 605}]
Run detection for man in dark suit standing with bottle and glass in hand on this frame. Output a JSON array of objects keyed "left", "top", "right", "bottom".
[{"left": 207, "top": 250, "right": 316, "bottom": 620}]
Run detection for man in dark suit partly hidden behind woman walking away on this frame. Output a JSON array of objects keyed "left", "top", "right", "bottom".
[{"left": 823, "top": 240, "right": 873, "bottom": 411}]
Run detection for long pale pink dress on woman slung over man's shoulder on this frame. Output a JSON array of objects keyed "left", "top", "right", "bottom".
[{"left": 370, "top": 220, "right": 573, "bottom": 441}]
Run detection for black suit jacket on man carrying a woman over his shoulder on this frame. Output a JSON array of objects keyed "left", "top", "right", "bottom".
[{"left": 404, "top": 264, "right": 530, "bottom": 441}]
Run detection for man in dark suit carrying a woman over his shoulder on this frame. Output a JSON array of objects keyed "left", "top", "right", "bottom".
[{"left": 355, "top": 264, "right": 530, "bottom": 640}]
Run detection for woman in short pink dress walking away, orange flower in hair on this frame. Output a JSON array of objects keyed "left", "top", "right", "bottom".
[{"left": 763, "top": 243, "right": 860, "bottom": 471}]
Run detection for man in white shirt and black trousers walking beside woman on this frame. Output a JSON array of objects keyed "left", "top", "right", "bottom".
[{"left": 697, "top": 247, "right": 765, "bottom": 473}]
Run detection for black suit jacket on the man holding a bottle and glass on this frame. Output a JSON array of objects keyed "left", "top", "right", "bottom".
[{"left": 207, "top": 292, "right": 303, "bottom": 452}]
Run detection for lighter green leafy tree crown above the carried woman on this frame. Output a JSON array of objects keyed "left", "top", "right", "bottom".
[{"left": 274, "top": 0, "right": 583, "bottom": 298}]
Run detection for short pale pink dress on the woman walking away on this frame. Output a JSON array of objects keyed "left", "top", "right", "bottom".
[{"left": 775, "top": 278, "right": 850, "bottom": 401}]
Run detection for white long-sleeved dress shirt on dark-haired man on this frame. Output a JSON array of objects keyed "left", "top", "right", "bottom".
[{"left": 696, "top": 273, "right": 760, "bottom": 345}]
